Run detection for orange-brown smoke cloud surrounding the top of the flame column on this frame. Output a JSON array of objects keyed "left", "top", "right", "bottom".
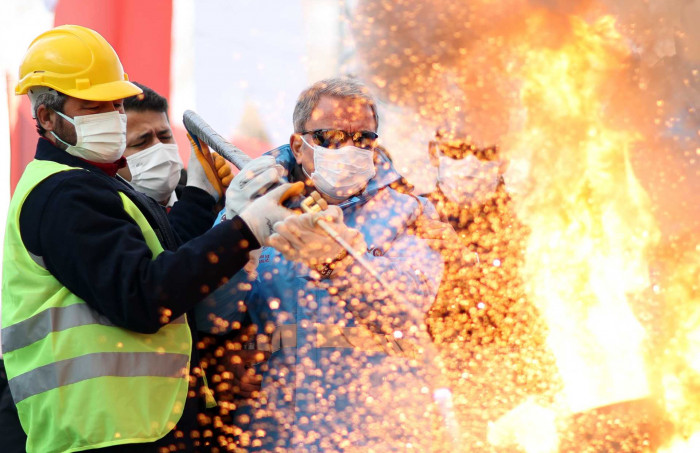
[{"left": 352, "top": 0, "right": 700, "bottom": 237}]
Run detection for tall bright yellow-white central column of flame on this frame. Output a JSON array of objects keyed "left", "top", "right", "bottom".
[{"left": 506, "top": 16, "right": 659, "bottom": 412}]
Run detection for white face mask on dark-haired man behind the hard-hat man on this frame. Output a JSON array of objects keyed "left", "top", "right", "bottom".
[{"left": 126, "top": 142, "right": 183, "bottom": 203}]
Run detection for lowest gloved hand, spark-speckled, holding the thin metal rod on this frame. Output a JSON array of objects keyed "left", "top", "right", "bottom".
[{"left": 268, "top": 206, "right": 367, "bottom": 277}]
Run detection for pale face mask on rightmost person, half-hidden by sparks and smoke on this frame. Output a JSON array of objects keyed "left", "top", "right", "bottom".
[{"left": 438, "top": 155, "right": 501, "bottom": 204}]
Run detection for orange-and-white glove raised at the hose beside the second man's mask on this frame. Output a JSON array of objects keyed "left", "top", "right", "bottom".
[{"left": 187, "top": 134, "right": 231, "bottom": 201}]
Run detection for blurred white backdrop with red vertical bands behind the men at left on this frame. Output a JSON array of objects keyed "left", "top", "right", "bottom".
[{"left": 0, "top": 0, "right": 356, "bottom": 192}]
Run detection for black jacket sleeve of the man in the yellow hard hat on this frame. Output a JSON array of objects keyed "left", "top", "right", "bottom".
[{"left": 20, "top": 171, "right": 259, "bottom": 333}]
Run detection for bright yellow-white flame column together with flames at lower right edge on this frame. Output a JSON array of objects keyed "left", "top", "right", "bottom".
[{"left": 508, "top": 16, "right": 700, "bottom": 452}]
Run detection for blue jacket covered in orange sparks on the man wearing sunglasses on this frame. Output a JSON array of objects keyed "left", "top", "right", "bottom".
[{"left": 198, "top": 146, "right": 443, "bottom": 452}]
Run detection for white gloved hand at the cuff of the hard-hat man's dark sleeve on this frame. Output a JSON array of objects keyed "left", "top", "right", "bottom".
[{"left": 238, "top": 182, "right": 304, "bottom": 245}]
